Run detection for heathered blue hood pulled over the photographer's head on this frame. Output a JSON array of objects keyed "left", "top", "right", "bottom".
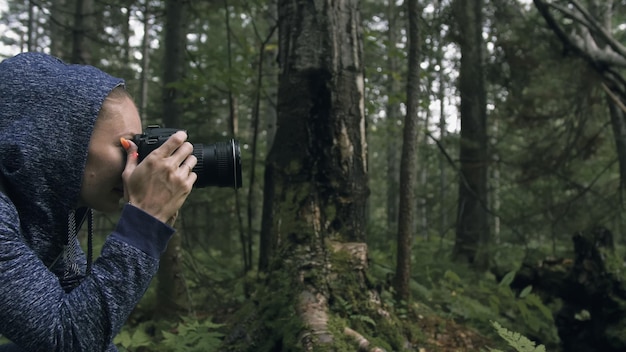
[{"left": 0, "top": 53, "right": 124, "bottom": 261}]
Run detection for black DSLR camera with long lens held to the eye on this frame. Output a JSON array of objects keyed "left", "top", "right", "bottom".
[{"left": 133, "top": 126, "right": 241, "bottom": 189}]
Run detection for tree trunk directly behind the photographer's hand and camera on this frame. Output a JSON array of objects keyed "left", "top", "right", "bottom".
[{"left": 156, "top": 0, "right": 190, "bottom": 316}]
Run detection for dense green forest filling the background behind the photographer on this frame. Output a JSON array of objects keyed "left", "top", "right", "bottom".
[{"left": 0, "top": 0, "right": 626, "bottom": 351}]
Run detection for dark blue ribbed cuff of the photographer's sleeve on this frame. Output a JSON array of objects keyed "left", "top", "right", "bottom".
[{"left": 111, "top": 204, "right": 175, "bottom": 259}]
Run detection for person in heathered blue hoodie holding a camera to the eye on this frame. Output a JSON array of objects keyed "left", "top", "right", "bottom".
[{"left": 0, "top": 53, "right": 197, "bottom": 352}]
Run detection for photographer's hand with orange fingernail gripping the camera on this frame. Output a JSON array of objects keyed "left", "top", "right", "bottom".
[{"left": 122, "top": 131, "right": 198, "bottom": 224}]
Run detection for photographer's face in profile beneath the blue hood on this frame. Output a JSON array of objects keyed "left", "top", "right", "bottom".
[{"left": 80, "top": 96, "right": 141, "bottom": 212}]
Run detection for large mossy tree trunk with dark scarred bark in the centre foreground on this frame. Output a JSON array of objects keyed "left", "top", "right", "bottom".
[{"left": 220, "top": 0, "right": 399, "bottom": 352}]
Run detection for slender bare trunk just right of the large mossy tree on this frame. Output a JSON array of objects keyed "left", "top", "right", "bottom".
[{"left": 394, "top": 0, "right": 421, "bottom": 301}]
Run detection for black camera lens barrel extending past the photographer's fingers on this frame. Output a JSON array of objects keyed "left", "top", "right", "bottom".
[{"left": 193, "top": 139, "right": 241, "bottom": 189}]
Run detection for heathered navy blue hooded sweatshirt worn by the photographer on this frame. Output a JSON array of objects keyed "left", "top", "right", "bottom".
[{"left": 0, "top": 53, "right": 174, "bottom": 352}]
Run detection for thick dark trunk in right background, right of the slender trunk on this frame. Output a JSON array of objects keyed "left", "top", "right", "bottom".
[{"left": 453, "top": 0, "right": 489, "bottom": 270}]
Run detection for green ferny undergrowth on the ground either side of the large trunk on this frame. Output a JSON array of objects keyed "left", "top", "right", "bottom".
[{"left": 109, "top": 234, "right": 604, "bottom": 352}]
